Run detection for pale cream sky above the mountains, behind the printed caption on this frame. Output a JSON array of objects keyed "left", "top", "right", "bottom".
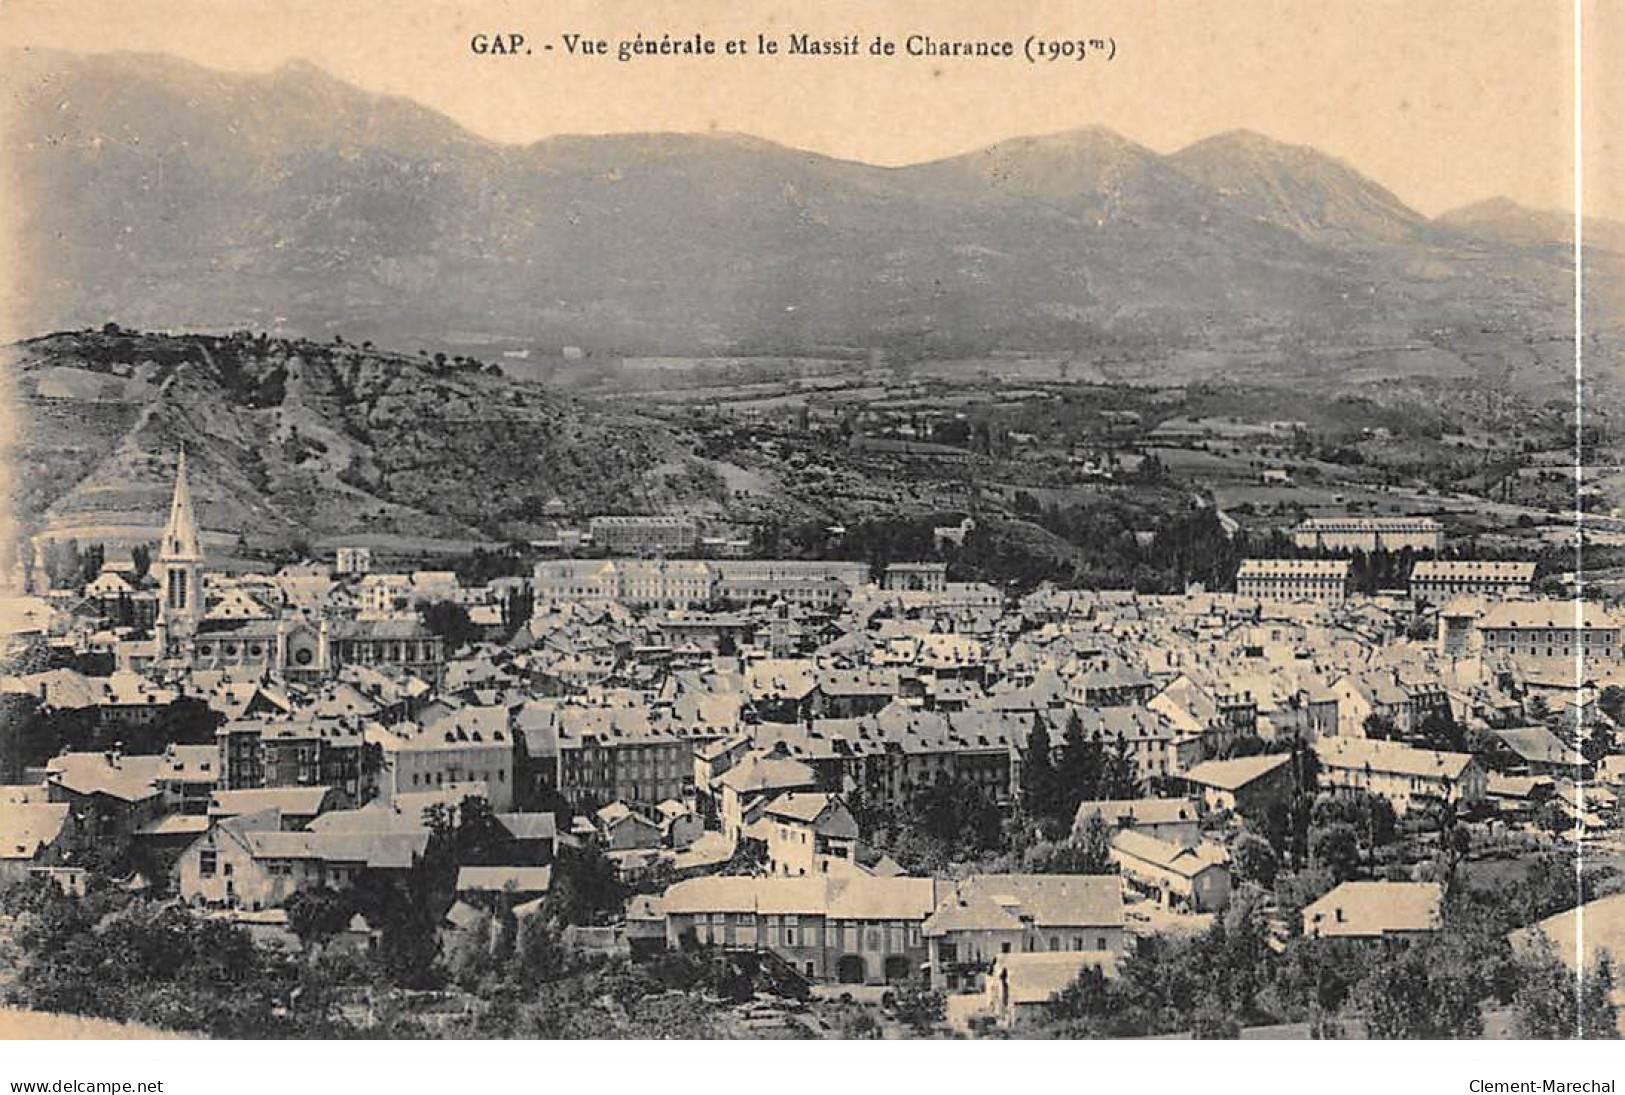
[{"left": 0, "top": 0, "right": 1625, "bottom": 219}]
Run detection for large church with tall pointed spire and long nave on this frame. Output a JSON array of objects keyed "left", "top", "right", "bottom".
[{"left": 137, "top": 448, "right": 445, "bottom": 686}]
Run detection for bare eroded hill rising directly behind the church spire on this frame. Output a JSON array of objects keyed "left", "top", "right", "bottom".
[{"left": 5, "top": 331, "right": 741, "bottom": 548}]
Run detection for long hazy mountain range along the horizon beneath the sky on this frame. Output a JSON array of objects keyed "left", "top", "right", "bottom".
[{"left": 8, "top": 52, "right": 1625, "bottom": 387}]
